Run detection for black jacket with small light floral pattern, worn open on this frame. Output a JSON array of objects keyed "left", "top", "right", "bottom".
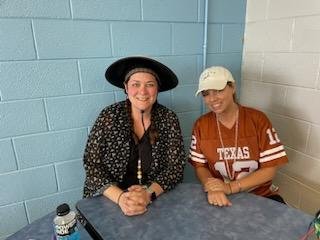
[{"left": 83, "top": 101, "right": 186, "bottom": 197}]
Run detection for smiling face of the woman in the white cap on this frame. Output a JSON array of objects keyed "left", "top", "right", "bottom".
[{"left": 202, "top": 83, "right": 235, "bottom": 115}]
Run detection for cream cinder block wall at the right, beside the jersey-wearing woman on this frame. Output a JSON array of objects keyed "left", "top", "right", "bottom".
[{"left": 241, "top": 0, "right": 320, "bottom": 214}]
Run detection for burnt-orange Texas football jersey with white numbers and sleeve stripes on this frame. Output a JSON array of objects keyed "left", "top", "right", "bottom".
[{"left": 189, "top": 106, "right": 288, "bottom": 196}]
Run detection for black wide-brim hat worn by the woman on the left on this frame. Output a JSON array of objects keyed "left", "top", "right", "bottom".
[{"left": 105, "top": 56, "right": 178, "bottom": 92}]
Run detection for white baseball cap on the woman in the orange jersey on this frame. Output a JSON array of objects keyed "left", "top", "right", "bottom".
[{"left": 196, "top": 66, "right": 235, "bottom": 96}]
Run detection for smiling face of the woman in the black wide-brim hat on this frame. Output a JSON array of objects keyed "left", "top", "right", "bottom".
[{"left": 125, "top": 72, "right": 158, "bottom": 112}]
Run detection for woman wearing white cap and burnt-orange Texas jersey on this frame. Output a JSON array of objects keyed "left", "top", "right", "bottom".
[{"left": 189, "top": 66, "right": 288, "bottom": 207}]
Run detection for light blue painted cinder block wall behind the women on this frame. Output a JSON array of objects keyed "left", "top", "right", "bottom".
[{"left": 0, "top": 0, "right": 245, "bottom": 236}]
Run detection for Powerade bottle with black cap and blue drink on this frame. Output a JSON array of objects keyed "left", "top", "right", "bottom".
[{"left": 53, "top": 203, "right": 80, "bottom": 240}]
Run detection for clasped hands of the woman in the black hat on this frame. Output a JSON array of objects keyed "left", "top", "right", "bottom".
[{"left": 119, "top": 185, "right": 150, "bottom": 216}]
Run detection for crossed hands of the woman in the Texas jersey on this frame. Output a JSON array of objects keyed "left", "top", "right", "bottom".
[{"left": 204, "top": 178, "right": 232, "bottom": 207}]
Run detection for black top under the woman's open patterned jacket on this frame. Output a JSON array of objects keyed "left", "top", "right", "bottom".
[{"left": 119, "top": 129, "right": 152, "bottom": 190}]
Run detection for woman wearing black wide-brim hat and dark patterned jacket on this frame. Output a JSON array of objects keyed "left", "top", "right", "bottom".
[{"left": 84, "top": 57, "right": 185, "bottom": 216}]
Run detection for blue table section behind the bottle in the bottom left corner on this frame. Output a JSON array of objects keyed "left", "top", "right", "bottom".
[{"left": 6, "top": 212, "right": 92, "bottom": 240}]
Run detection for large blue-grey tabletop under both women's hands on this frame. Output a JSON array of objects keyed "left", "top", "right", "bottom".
[{"left": 76, "top": 184, "right": 313, "bottom": 240}]
